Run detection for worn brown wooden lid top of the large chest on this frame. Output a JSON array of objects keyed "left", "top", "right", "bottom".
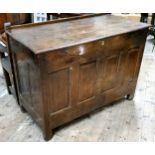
[{"left": 8, "top": 15, "right": 148, "bottom": 54}]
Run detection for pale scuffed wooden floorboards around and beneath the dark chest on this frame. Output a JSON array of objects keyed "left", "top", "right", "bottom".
[{"left": 0, "top": 37, "right": 155, "bottom": 142}]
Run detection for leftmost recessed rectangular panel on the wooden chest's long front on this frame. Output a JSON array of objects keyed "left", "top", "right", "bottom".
[{"left": 49, "top": 69, "right": 70, "bottom": 112}]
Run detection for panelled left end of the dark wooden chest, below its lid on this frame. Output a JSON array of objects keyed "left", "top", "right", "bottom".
[{"left": 9, "top": 38, "right": 43, "bottom": 127}]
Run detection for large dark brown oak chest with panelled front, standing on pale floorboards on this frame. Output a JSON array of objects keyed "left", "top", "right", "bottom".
[{"left": 6, "top": 14, "right": 149, "bottom": 140}]
